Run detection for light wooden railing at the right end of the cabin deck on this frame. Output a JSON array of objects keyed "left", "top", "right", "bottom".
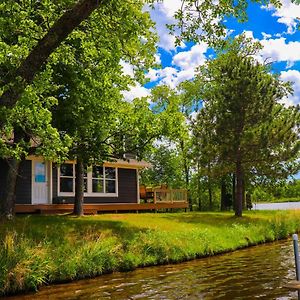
[{"left": 153, "top": 188, "right": 187, "bottom": 203}]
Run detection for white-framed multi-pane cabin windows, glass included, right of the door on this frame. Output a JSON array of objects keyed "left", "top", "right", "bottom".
[{"left": 58, "top": 163, "right": 117, "bottom": 197}]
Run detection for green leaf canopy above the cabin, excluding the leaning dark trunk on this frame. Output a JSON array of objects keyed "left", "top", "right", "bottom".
[{"left": 0, "top": 0, "right": 156, "bottom": 161}]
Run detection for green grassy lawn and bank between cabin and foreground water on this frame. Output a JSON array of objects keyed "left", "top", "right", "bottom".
[{"left": 0, "top": 211, "right": 300, "bottom": 295}]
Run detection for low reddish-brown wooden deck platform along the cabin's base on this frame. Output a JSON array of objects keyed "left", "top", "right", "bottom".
[{"left": 15, "top": 201, "right": 188, "bottom": 214}]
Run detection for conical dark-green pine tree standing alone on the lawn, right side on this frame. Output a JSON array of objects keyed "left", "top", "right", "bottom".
[{"left": 186, "top": 36, "right": 299, "bottom": 216}]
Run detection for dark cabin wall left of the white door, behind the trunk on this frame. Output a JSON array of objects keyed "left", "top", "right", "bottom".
[{"left": 0, "top": 160, "right": 31, "bottom": 204}]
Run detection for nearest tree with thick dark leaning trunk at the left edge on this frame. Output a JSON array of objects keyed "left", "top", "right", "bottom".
[{"left": 0, "top": 0, "right": 284, "bottom": 215}]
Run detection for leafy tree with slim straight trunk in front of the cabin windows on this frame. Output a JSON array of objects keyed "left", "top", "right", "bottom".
[{"left": 48, "top": 2, "right": 155, "bottom": 215}]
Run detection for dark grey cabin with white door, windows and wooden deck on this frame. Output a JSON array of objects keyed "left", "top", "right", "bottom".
[{"left": 0, "top": 156, "right": 187, "bottom": 214}]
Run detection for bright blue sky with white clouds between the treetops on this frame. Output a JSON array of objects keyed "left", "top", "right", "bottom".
[{"left": 124, "top": 0, "right": 300, "bottom": 106}]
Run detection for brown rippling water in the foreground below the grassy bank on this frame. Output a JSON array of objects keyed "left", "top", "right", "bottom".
[{"left": 10, "top": 240, "right": 298, "bottom": 300}]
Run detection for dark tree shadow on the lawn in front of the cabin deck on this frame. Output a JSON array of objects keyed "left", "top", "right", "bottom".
[{"left": 0, "top": 215, "right": 149, "bottom": 245}]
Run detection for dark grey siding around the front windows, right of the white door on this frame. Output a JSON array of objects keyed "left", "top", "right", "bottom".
[{"left": 52, "top": 167, "right": 138, "bottom": 204}]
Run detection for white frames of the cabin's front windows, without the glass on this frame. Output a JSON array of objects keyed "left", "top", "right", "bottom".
[{"left": 57, "top": 162, "right": 119, "bottom": 197}]
